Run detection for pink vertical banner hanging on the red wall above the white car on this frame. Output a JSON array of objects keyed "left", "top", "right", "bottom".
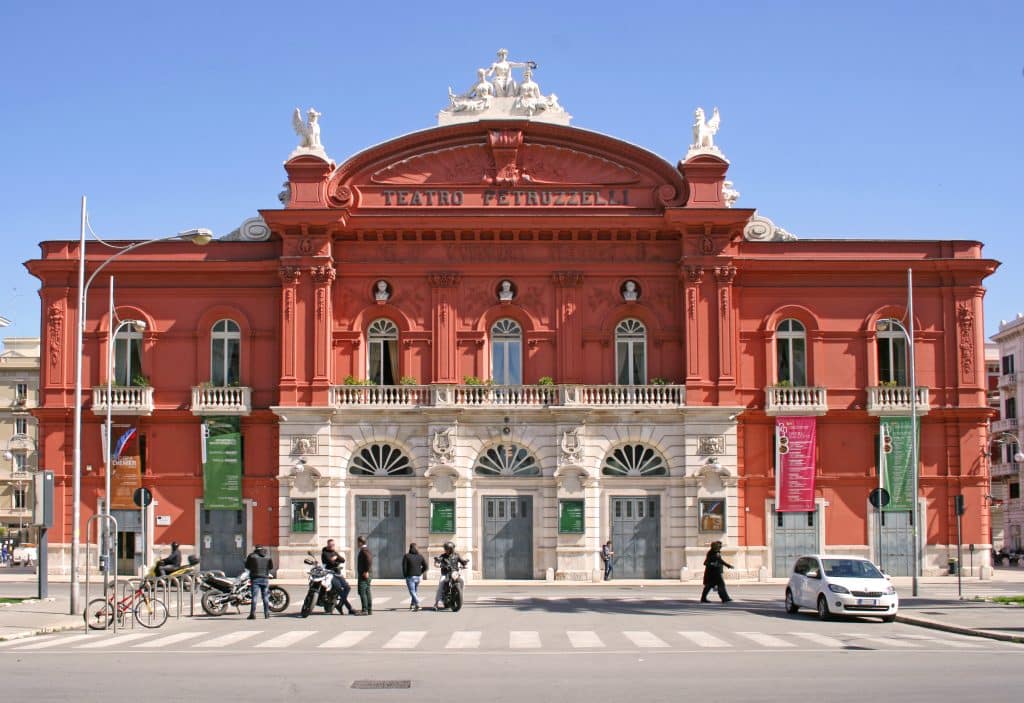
[{"left": 775, "top": 418, "right": 817, "bottom": 513}]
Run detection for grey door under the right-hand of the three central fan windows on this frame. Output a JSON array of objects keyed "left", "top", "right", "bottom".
[{"left": 610, "top": 495, "right": 662, "bottom": 578}]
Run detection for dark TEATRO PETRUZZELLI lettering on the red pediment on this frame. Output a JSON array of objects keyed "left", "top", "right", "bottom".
[{"left": 381, "top": 188, "right": 630, "bottom": 208}]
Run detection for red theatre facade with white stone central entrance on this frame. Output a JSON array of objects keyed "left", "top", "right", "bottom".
[{"left": 28, "top": 74, "right": 996, "bottom": 580}]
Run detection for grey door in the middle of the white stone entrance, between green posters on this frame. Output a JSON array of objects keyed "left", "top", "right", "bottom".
[{"left": 483, "top": 495, "right": 534, "bottom": 578}]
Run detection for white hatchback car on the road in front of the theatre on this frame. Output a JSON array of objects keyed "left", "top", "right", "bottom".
[{"left": 785, "top": 555, "right": 899, "bottom": 622}]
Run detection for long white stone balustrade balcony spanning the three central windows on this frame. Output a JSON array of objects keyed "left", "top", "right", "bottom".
[{"left": 329, "top": 385, "right": 686, "bottom": 408}]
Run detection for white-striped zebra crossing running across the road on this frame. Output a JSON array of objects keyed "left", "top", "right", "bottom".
[{"left": 0, "top": 628, "right": 1024, "bottom": 653}]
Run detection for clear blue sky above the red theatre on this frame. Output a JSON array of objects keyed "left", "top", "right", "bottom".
[{"left": 0, "top": 0, "right": 1024, "bottom": 336}]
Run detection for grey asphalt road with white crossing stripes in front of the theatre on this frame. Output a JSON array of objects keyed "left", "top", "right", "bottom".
[{"left": 0, "top": 586, "right": 1024, "bottom": 703}]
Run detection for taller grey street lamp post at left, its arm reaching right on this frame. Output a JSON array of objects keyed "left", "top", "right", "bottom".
[{"left": 71, "top": 195, "right": 213, "bottom": 615}]
